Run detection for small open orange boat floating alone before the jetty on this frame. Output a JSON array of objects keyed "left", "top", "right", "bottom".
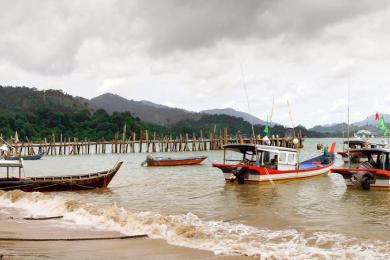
[{"left": 142, "top": 155, "right": 207, "bottom": 166}]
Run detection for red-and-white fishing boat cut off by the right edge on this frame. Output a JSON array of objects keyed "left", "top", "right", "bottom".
[{"left": 332, "top": 148, "right": 390, "bottom": 190}]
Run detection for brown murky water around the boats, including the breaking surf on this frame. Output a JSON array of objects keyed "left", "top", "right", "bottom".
[{"left": 0, "top": 139, "right": 390, "bottom": 258}]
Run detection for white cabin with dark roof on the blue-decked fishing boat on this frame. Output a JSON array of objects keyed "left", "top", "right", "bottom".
[{"left": 223, "top": 144, "right": 298, "bottom": 170}]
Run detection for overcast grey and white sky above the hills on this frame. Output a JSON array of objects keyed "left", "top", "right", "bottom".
[{"left": 0, "top": 0, "right": 390, "bottom": 127}]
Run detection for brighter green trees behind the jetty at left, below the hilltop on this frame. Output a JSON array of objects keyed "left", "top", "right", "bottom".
[{"left": 0, "top": 109, "right": 168, "bottom": 140}]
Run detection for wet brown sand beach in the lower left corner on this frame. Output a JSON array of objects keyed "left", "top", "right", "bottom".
[{"left": 0, "top": 210, "right": 242, "bottom": 260}]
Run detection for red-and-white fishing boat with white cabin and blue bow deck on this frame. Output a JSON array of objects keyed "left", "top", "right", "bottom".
[{"left": 213, "top": 144, "right": 335, "bottom": 183}]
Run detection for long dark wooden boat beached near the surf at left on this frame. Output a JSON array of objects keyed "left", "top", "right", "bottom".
[{"left": 0, "top": 162, "right": 123, "bottom": 192}]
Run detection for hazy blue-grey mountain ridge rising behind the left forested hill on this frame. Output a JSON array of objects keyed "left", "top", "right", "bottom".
[{"left": 88, "top": 93, "right": 201, "bottom": 125}]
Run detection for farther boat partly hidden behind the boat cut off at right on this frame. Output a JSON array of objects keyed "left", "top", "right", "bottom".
[{"left": 337, "top": 137, "right": 385, "bottom": 163}]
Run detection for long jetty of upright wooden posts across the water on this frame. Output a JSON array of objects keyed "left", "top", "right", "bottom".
[{"left": 0, "top": 128, "right": 303, "bottom": 155}]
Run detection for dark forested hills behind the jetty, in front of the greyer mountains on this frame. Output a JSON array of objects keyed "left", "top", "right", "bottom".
[{"left": 0, "top": 86, "right": 327, "bottom": 141}]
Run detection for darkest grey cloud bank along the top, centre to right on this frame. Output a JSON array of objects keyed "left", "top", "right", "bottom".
[{"left": 139, "top": 0, "right": 386, "bottom": 52}]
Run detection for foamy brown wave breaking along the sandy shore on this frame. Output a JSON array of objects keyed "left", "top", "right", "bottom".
[{"left": 0, "top": 191, "right": 390, "bottom": 259}]
